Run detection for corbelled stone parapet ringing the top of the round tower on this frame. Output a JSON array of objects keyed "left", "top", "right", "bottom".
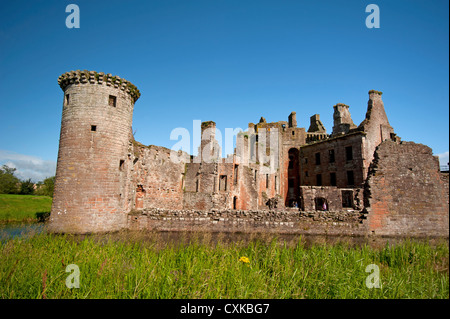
[{"left": 58, "top": 70, "right": 141, "bottom": 102}]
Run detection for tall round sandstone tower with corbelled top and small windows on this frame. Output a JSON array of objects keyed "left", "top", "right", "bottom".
[{"left": 50, "top": 71, "right": 140, "bottom": 233}]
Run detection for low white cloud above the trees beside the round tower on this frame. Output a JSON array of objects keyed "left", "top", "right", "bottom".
[{"left": 0, "top": 150, "right": 56, "bottom": 182}]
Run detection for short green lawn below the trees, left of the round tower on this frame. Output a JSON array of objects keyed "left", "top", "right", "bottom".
[{"left": 0, "top": 194, "right": 52, "bottom": 222}]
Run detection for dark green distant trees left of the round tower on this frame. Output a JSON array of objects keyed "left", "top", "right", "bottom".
[{"left": 0, "top": 165, "right": 55, "bottom": 197}]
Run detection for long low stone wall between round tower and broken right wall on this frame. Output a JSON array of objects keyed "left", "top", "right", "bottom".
[{"left": 128, "top": 209, "right": 365, "bottom": 236}]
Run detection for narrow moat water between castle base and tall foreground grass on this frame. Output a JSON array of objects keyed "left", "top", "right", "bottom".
[{"left": 0, "top": 223, "right": 448, "bottom": 248}]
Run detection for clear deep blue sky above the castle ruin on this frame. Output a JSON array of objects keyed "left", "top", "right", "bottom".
[{"left": 0, "top": 0, "right": 449, "bottom": 180}]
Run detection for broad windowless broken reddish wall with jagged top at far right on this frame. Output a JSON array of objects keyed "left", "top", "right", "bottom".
[{"left": 364, "top": 141, "right": 449, "bottom": 236}]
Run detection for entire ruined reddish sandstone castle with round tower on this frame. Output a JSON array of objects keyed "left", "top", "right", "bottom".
[{"left": 50, "top": 71, "right": 449, "bottom": 237}]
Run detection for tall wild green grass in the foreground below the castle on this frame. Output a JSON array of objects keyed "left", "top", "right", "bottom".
[{"left": 0, "top": 234, "right": 449, "bottom": 299}]
